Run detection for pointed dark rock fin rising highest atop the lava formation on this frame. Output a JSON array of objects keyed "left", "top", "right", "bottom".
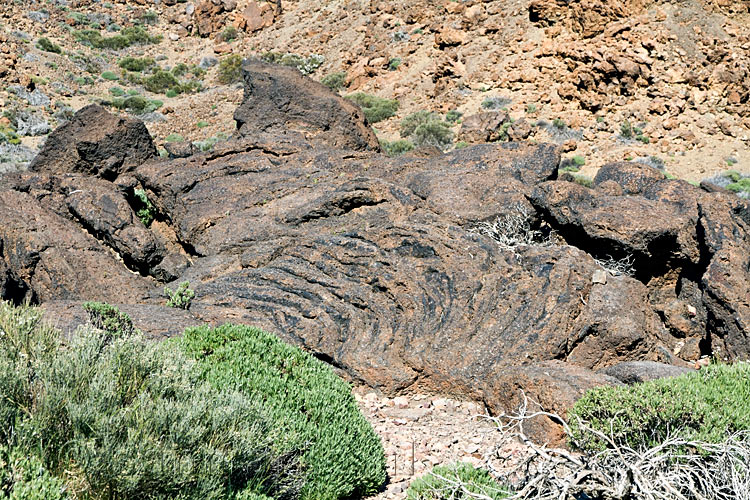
[{"left": 234, "top": 60, "right": 380, "bottom": 151}]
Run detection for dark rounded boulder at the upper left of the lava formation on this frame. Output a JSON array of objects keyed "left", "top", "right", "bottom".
[{"left": 29, "top": 104, "right": 157, "bottom": 180}]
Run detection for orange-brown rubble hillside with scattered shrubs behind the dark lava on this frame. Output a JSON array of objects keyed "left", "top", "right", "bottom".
[{"left": 0, "top": 0, "right": 750, "bottom": 188}]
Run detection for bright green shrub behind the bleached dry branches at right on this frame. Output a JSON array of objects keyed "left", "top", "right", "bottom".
[{"left": 569, "top": 363, "right": 750, "bottom": 451}]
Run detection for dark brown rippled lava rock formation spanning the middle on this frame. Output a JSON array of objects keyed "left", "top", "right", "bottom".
[{"left": 0, "top": 56, "right": 750, "bottom": 448}]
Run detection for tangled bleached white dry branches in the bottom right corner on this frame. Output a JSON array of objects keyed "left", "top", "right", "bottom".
[{"left": 476, "top": 395, "right": 750, "bottom": 500}]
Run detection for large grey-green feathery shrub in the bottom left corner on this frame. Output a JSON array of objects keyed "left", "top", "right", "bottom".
[{"left": 0, "top": 303, "right": 300, "bottom": 500}]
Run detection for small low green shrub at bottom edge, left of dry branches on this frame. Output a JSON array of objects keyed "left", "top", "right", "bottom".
[{"left": 406, "top": 462, "right": 508, "bottom": 500}]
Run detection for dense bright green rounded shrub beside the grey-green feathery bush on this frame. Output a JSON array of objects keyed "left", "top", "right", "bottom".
[{"left": 179, "top": 325, "right": 385, "bottom": 500}]
